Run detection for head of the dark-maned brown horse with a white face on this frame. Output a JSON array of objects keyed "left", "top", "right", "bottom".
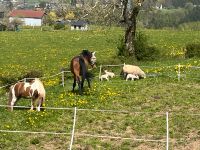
[{"left": 81, "top": 50, "right": 96, "bottom": 67}]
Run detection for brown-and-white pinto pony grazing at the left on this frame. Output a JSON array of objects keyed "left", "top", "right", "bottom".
[{"left": 8, "top": 78, "right": 45, "bottom": 111}]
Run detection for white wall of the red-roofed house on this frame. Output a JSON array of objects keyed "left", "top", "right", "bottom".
[{"left": 9, "top": 17, "right": 42, "bottom": 26}]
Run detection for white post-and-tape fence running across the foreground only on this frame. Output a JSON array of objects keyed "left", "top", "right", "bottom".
[{"left": 0, "top": 105, "right": 170, "bottom": 150}]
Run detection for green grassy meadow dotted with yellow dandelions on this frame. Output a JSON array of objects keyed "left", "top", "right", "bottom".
[{"left": 0, "top": 28, "right": 200, "bottom": 150}]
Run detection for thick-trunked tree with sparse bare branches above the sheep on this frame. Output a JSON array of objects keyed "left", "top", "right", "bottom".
[{"left": 82, "top": 0, "right": 144, "bottom": 57}]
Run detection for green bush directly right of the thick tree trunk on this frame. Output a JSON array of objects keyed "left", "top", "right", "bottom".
[{"left": 135, "top": 32, "right": 160, "bottom": 61}]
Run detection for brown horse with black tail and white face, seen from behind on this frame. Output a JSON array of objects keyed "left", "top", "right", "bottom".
[{"left": 70, "top": 50, "right": 96, "bottom": 95}]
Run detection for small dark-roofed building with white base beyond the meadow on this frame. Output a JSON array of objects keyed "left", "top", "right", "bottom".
[{"left": 71, "top": 20, "right": 88, "bottom": 31}]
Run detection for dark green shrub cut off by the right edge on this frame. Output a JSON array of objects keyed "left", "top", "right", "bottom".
[{"left": 185, "top": 43, "right": 200, "bottom": 58}]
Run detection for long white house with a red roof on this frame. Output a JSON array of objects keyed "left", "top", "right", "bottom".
[{"left": 9, "top": 9, "right": 45, "bottom": 26}]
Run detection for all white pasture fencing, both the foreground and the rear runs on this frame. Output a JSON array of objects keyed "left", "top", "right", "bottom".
[{"left": 0, "top": 64, "right": 200, "bottom": 150}]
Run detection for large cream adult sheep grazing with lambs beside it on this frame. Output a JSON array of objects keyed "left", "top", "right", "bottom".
[{"left": 122, "top": 64, "right": 146, "bottom": 78}]
